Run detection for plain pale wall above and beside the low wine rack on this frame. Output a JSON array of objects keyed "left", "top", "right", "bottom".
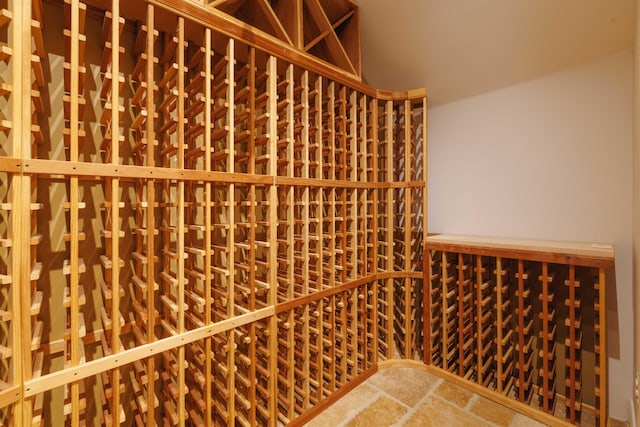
[{"left": 429, "top": 51, "right": 633, "bottom": 419}]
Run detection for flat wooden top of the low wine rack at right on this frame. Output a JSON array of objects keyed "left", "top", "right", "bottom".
[{"left": 425, "top": 234, "right": 615, "bottom": 268}]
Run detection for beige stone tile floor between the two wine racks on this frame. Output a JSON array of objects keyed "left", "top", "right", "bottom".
[{"left": 306, "top": 367, "right": 625, "bottom": 427}]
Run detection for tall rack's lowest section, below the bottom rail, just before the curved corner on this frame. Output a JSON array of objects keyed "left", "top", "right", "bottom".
[{"left": 278, "top": 282, "right": 377, "bottom": 423}]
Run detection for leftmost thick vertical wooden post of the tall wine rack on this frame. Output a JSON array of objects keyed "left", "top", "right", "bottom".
[{"left": 12, "top": 2, "right": 35, "bottom": 425}]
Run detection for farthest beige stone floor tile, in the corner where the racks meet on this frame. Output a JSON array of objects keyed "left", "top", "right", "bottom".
[{"left": 367, "top": 368, "right": 439, "bottom": 406}]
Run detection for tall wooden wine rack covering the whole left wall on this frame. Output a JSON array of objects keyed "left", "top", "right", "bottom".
[{"left": 0, "top": 0, "right": 430, "bottom": 426}]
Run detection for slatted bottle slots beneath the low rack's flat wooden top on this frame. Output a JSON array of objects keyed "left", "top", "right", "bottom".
[{"left": 426, "top": 250, "right": 604, "bottom": 423}]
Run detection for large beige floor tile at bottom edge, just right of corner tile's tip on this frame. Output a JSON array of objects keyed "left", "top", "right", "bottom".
[{"left": 404, "top": 396, "right": 490, "bottom": 427}]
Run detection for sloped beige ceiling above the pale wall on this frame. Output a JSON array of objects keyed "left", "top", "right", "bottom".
[{"left": 359, "top": 0, "right": 635, "bottom": 105}]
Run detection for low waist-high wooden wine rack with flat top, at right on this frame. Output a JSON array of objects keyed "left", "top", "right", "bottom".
[{"left": 424, "top": 235, "right": 614, "bottom": 426}]
